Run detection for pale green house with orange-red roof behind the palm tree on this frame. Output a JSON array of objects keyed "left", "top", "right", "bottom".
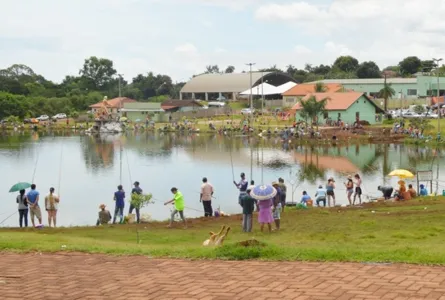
[{"left": 292, "top": 92, "right": 383, "bottom": 125}]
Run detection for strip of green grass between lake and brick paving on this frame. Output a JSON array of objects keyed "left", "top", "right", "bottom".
[{"left": 0, "top": 197, "right": 445, "bottom": 264}]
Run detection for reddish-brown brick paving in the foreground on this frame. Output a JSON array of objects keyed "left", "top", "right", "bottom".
[{"left": 0, "top": 253, "right": 445, "bottom": 300}]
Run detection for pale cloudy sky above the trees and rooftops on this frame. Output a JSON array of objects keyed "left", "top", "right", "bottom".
[{"left": 0, "top": 0, "right": 445, "bottom": 82}]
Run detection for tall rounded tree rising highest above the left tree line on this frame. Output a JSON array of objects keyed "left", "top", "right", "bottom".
[{"left": 79, "top": 56, "right": 117, "bottom": 91}]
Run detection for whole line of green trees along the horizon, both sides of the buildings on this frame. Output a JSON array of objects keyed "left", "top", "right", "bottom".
[{"left": 0, "top": 56, "right": 445, "bottom": 119}]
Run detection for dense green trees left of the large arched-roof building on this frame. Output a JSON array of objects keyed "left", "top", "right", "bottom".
[{"left": 0, "top": 56, "right": 184, "bottom": 119}]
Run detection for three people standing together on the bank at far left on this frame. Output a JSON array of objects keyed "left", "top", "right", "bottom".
[{"left": 16, "top": 184, "right": 60, "bottom": 227}]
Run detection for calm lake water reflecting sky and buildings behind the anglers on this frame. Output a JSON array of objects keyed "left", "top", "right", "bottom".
[{"left": 0, "top": 132, "right": 445, "bottom": 226}]
